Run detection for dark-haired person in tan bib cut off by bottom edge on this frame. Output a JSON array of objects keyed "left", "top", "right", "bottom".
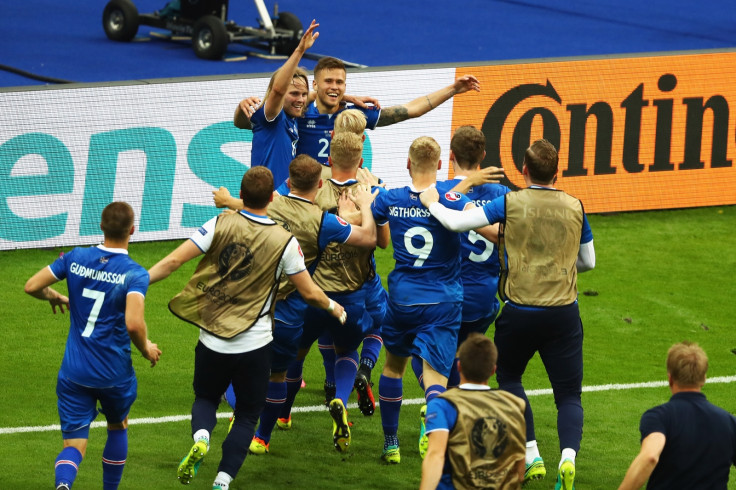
[{"left": 420, "top": 332, "right": 526, "bottom": 490}]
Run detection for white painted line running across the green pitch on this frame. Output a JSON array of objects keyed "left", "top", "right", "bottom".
[{"left": 0, "top": 376, "right": 736, "bottom": 434}]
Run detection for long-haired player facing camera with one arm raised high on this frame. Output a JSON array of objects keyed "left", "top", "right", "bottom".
[{"left": 234, "top": 20, "right": 319, "bottom": 185}]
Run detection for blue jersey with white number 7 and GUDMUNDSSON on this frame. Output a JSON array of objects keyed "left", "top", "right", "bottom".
[{"left": 49, "top": 245, "right": 148, "bottom": 388}]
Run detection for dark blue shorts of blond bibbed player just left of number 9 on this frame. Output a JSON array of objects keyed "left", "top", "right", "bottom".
[{"left": 299, "top": 290, "right": 373, "bottom": 351}]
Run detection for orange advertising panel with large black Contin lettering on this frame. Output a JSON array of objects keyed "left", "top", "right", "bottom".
[{"left": 452, "top": 53, "right": 736, "bottom": 213}]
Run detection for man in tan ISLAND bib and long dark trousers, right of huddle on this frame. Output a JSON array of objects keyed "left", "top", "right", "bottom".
[{"left": 421, "top": 140, "right": 595, "bottom": 490}]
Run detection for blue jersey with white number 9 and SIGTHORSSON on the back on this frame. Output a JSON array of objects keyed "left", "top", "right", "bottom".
[{"left": 372, "top": 182, "right": 470, "bottom": 305}]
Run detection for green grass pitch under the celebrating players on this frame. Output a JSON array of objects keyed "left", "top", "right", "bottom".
[{"left": 0, "top": 207, "right": 736, "bottom": 490}]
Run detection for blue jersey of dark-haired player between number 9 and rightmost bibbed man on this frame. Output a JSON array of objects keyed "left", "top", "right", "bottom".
[{"left": 447, "top": 179, "right": 511, "bottom": 322}]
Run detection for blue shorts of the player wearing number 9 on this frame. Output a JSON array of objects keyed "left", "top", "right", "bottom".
[{"left": 381, "top": 302, "right": 462, "bottom": 377}]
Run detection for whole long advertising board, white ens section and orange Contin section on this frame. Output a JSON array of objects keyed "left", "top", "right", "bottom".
[{"left": 0, "top": 52, "right": 736, "bottom": 249}]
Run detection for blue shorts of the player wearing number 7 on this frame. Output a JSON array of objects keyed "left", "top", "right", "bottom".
[{"left": 56, "top": 375, "right": 138, "bottom": 439}]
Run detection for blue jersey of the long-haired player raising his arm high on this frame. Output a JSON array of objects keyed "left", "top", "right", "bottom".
[{"left": 250, "top": 105, "right": 299, "bottom": 187}]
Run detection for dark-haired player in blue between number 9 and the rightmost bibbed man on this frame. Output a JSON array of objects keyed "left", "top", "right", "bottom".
[{"left": 412, "top": 126, "right": 511, "bottom": 386}]
